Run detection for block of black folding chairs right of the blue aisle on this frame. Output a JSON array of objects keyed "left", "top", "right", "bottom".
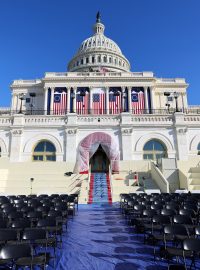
[{"left": 120, "top": 193, "right": 200, "bottom": 269}]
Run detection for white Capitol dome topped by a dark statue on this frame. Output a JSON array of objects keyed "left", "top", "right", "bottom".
[{"left": 68, "top": 12, "right": 130, "bottom": 72}]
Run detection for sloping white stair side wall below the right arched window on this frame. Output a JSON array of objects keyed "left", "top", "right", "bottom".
[{"left": 151, "top": 161, "right": 169, "bottom": 193}]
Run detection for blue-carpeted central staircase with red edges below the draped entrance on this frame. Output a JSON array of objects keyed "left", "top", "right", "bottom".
[{"left": 88, "top": 173, "right": 112, "bottom": 204}]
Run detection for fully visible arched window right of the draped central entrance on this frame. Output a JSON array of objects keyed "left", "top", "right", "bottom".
[{"left": 143, "top": 140, "right": 167, "bottom": 163}]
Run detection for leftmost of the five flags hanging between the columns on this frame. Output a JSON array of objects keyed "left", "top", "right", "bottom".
[{"left": 53, "top": 91, "right": 67, "bottom": 115}]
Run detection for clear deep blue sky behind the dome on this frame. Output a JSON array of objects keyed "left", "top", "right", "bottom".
[{"left": 0, "top": 0, "right": 200, "bottom": 107}]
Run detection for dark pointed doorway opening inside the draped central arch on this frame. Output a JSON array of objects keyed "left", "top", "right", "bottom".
[{"left": 90, "top": 145, "right": 110, "bottom": 173}]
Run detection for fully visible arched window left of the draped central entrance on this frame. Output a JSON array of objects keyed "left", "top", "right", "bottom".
[{"left": 33, "top": 140, "right": 56, "bottom": 161}]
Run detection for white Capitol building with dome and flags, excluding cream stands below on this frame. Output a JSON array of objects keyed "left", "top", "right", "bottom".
[{"left": 0, "top": 14, "right": 200, "bottom": 194}]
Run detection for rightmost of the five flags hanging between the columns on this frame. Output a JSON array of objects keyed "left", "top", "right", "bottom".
[{"left": 131, "top": 91, "right": 144, "bottom": 114}]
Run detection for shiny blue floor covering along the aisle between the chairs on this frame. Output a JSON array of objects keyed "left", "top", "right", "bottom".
[{"left": 56, "top": 204, "right": 196, "bottom": 270}]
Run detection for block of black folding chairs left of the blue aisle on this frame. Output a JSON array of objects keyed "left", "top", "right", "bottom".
[{"left": 0, "top": 194, "right": 78, "bottom": 269}]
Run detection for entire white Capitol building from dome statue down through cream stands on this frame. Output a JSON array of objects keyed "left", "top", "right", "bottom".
[{"left": 0, "top": 13, "right": 200, "bottom": 202}]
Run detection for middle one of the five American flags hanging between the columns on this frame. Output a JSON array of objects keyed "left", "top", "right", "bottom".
[{"left": 92, "top": 93, "right": 106, "bottom": 114}]
